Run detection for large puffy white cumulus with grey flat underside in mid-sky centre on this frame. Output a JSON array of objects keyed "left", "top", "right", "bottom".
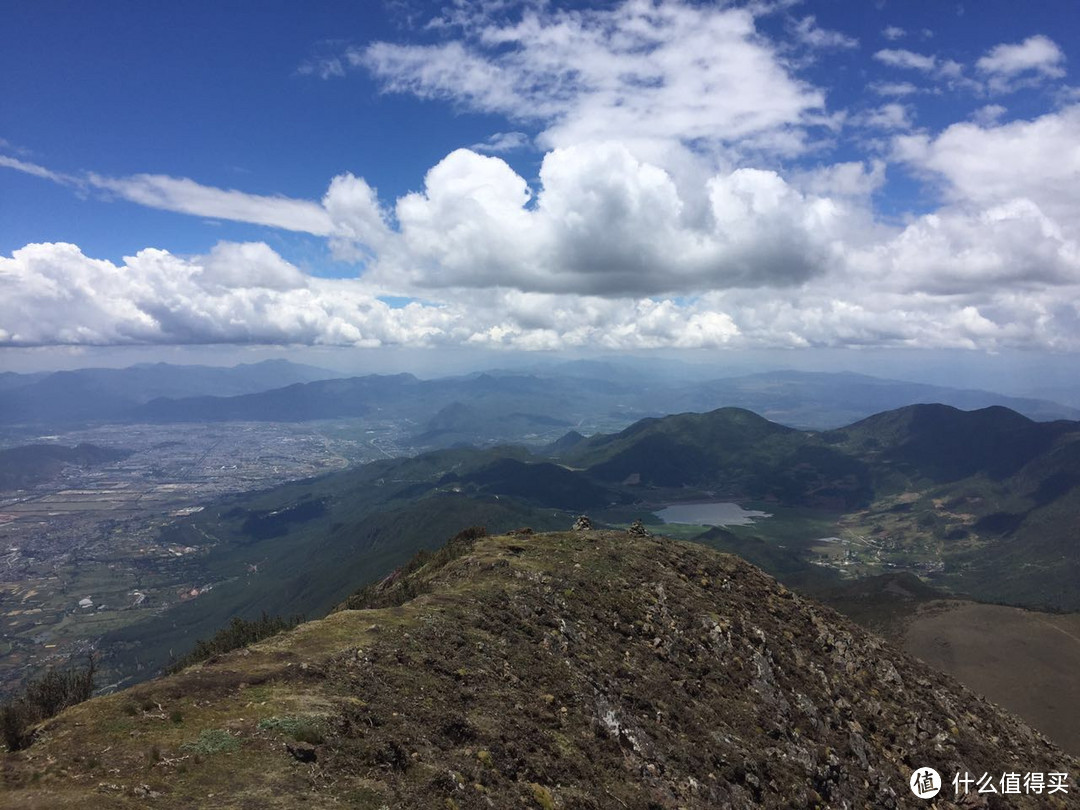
[{"left": 372, "top": 143, "right": 846, "bottom": 296}]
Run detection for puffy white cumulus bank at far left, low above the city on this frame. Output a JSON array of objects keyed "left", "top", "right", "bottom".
[{"left": 0, "top": 243, "right": 445, "bottom": 346}]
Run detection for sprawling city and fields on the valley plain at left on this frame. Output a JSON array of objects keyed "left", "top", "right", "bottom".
[{"left": 0, "top": 420, "right": 410, "bottom": 693}]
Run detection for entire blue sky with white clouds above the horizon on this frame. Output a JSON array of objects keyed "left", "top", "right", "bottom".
[{"left": 0, "top": 0, "right": 1080, "bottom": 380}]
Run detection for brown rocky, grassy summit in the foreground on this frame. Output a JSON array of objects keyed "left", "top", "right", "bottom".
[{"left": 0, "top": 529, "right": 1080, "bottom": 810}]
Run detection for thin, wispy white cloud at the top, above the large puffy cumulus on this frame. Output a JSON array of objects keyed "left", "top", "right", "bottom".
[{"left": 349, "top": 0, "right": 824, "bottom": 159}]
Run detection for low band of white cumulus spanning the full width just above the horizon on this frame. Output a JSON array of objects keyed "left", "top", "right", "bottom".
[{"left": 6, "top": 230, "right": 1080, "bottom": 350}]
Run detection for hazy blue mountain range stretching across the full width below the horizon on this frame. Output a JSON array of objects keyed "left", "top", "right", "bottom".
[{"left": 0, "top": 361, "right": 1080, "bottom": 438}]
